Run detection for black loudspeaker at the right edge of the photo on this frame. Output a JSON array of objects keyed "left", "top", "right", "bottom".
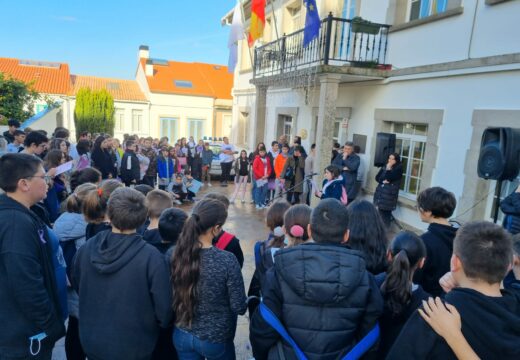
[{"left": 477, "top": 128, "right": 520, "bottom": 180}]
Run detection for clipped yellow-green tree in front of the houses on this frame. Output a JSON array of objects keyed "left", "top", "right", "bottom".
[{"left": 74, "top": 88, "right": 115, "bottom": 138}]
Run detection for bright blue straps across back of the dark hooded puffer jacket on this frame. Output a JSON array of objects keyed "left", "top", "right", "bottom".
[{"left": 258, "top": 302, "right": 380, "bottom": 360}]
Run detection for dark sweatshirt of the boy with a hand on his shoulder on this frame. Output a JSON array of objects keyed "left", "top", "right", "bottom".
[{"left": 387, "top": 288, "right": 520, "bottom": 360}]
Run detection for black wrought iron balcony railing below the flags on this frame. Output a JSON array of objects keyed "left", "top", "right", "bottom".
[{"left": 253, "top": 14, "right": 390, "bottom": 78}]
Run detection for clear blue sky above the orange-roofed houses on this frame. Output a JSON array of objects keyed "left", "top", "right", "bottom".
[{"left": 0, "top": 0, "right": 236, "bottom": 79}]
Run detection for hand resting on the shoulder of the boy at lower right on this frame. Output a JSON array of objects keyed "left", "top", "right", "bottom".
[{"left": 419, "top": 297, "right": 462, "bottom": 339}]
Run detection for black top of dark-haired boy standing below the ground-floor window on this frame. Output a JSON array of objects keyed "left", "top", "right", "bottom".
[{"left": 413, "top": 223, "right": 458, "bottom": 297}]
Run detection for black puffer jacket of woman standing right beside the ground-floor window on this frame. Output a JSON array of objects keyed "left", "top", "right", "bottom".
[{"left": 374, "top": 164, "right": 403, "bottom": 211}]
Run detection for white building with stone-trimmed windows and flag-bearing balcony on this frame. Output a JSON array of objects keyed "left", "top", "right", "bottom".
[{"left": 223, "top": 0, "right": 520, "bottom": 228}]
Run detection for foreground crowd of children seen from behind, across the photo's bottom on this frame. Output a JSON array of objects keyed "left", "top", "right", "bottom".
[{"left": 0, "top": 148, "right": 520, "bottom": 359}]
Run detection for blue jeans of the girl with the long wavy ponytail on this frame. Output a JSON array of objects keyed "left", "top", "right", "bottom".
[{"left": 173, "top": 327, "right": 235, "bottom": 360}]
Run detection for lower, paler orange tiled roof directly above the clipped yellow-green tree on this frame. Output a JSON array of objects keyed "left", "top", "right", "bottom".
[{"left": 69, "top": 75, "right": 147, "bottom": 101}]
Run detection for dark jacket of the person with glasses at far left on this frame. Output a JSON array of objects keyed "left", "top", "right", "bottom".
[{"left": 0, "top": 195, "right": 65, "bottom": 357}]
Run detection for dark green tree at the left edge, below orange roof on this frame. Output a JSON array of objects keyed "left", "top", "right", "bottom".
[{"left": 0, "top": 73, "right": 41, "bottom": 125}]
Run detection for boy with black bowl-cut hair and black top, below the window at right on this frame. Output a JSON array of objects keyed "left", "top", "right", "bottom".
[{"left": 413, "top": 186, "right": 458, "bottom": 296}]
